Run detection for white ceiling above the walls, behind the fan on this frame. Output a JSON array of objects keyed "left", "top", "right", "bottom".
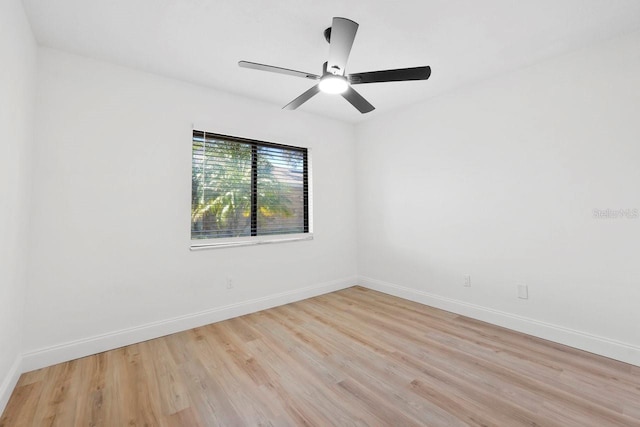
[{"left": 23, "top": 0, "right": 640, "bottom": 122}]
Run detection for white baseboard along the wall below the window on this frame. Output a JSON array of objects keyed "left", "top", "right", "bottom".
[{"left": 22, "top": 276, "right": 357, "bottom": 372}]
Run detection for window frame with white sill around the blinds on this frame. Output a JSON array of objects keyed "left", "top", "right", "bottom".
[{"left": 189, "top": 128, "right": 313, "bottom": 251}]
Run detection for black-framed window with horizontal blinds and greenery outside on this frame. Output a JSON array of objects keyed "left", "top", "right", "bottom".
[{"left": 191, "top": 130, "right": 309, "bottom": 247}]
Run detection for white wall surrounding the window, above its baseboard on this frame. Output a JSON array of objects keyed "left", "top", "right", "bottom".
[{"left": 25, "top": 49, "right": 356, "bottom": 369}]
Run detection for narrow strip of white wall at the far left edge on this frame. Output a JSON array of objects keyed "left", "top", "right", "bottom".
[{"left": 0, "top": 0, "right": 36, "bottom": 413}]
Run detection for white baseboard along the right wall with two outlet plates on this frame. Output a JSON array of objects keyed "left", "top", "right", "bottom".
[{"left": 358, "top": 276, "right": 640, "bottom": 366}]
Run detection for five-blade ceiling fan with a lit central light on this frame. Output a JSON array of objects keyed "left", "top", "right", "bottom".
[{"left": 238, "top": 17, "right": 431, "bottom": 114}]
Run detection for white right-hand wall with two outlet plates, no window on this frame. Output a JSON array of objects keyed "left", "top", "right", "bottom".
[{"left": 357, "top": 33, "right": 640, "bottom": 364}]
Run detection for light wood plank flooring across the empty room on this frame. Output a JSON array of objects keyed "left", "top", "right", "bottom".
[{"left": 0, "top": 287, "right": 640, "bottom": 427}]
